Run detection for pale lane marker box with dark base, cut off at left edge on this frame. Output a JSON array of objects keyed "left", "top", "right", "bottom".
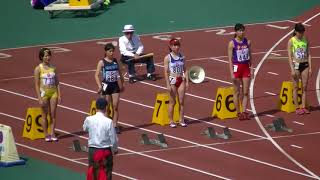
[{"left": 0, "top": 124, "right": 26, "bottom": 167}]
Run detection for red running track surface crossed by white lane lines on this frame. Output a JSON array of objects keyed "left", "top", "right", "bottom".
[{"left": 0, "top": 8, "right": 320, "bottom": 179}]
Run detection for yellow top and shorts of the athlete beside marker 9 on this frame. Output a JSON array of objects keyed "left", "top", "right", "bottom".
[{"left": 39, "top": 64, "right": 58, "bottom": 99}]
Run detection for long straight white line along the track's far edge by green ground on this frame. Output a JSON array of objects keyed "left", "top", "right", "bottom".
[{"left": 0, "top": 20, "right": 288, "bottom": 51}]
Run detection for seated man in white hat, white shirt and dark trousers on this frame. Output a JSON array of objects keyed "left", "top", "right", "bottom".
[{"left": 119, "top": 24, "right": 156, "bottom": 83}]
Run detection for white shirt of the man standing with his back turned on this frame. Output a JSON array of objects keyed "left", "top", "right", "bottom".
[{"left": 83, "top": 112, "right": 118, "bottom": 152}]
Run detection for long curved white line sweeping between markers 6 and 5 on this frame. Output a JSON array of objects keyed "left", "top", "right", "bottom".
[{"left": 250, "top": 13, "right": 320, "bottom": 179}]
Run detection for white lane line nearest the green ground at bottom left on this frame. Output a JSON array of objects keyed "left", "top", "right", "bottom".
[{"left": 16, "top": 142, "right": 137, "bottom": 180}]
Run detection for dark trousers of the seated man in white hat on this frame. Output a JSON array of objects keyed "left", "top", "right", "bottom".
[{"left": 121, "top": 55, "right": 155, "bottom": 76}]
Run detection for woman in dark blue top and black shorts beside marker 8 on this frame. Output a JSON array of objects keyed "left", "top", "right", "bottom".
[{"left": 95, "top": 43, "right": 124, "bottom": 134}]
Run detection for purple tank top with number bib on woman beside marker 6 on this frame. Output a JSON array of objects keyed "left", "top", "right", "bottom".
[{"left": 232, "top": 38, "right": 250, "bottom": 64}]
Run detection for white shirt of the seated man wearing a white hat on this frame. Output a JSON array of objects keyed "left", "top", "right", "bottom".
[{"left": 119, "top": 34, "right": 143, "bottom": 56}]
